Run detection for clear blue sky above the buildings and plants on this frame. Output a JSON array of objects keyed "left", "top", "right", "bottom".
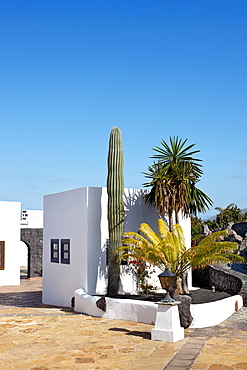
[{"left": 0, "top": 0, "right": 247, "bottom": 218}]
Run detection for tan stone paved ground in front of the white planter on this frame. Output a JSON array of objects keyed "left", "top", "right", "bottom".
[{"left": 0, "top": 279, "right": 247, "bottom": 370}]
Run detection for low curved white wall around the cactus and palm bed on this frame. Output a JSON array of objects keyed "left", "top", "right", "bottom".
[{"left": 74, "top": 289, "right": 243, "bottom": 328}]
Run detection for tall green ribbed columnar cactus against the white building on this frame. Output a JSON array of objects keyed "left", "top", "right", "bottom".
[{"left": 107, "top": 127, "right": 124, "bottom": 295}]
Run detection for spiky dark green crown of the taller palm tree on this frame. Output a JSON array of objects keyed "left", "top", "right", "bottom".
[{"left": 144, "top": 137, "right": 213, "bottom": 230}]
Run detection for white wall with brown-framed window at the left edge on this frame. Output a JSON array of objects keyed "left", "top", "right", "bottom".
[{"left": 0, "top": 201, "right": 21, "bottom": 286}]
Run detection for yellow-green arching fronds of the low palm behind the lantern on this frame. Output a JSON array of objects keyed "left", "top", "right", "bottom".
[{"left": 118, "top": 219, "right": 244, "bottom": 294}]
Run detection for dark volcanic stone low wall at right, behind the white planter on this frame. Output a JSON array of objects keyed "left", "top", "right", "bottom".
[{"left": 192, "top": 266, "right": 247, "bottom": 306}]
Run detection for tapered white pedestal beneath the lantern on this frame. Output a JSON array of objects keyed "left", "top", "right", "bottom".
[{"left": 151, "top": 301, "right": 184, "bottom": 342}]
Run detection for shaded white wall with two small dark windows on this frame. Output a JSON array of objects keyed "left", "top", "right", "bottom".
[{"left": 42, "top": 188, "right": 88, "bottom": 307}]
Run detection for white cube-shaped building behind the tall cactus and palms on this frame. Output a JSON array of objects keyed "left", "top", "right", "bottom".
[{"left": 43, "top": 187, "right": 190, "bottom": 307}]
